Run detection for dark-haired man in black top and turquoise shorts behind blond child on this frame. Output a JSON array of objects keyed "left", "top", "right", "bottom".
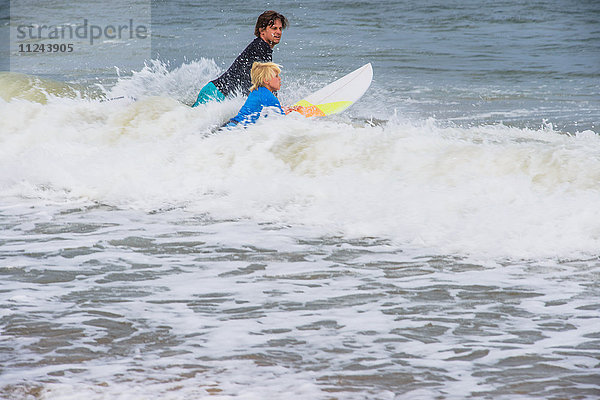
[{"left": 192, "top": 11, "right": 288, "bottom": 107}]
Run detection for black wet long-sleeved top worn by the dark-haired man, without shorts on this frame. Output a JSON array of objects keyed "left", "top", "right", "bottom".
[{"left": 212, "top": 38, "right": 273, "bottom": 96}]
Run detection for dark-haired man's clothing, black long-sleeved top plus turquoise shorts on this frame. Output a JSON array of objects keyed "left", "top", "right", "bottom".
[{"left": 192, "top": 38, "right": 273, "bottom": 107}]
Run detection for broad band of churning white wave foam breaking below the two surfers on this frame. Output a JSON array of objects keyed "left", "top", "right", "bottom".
[{"left": 0, "top": 60, "right": 600, "bottom": 258}]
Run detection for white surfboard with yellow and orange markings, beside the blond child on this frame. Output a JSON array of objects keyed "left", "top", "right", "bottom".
[{"left": 294, "top": 63, "right": 373, "bottom": 117}]
